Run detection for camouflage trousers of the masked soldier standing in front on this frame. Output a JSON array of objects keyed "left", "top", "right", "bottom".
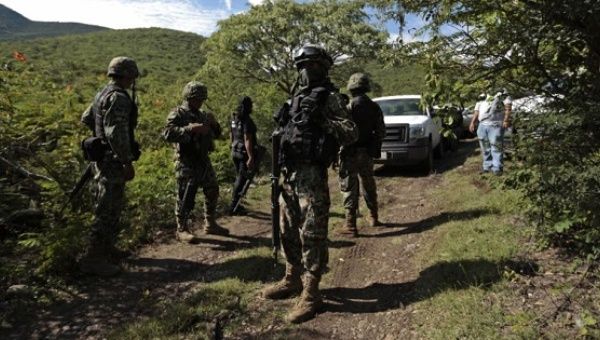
[{"left": 280, "top": 164, "right": 331, "bottom": 277}]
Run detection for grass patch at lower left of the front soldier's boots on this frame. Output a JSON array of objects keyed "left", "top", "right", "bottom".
[{"left": 108, "top": 247, "right": 283, "bottom": 339}]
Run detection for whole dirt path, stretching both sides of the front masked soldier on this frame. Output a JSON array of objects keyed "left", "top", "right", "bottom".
[{"left": 8, "top": 143, "right": 472, "bottom": 339}]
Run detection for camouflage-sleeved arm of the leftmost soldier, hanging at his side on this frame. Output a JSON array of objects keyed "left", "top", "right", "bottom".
[{"left": 103, "top": 92, "right": 133, "bottom": 164}]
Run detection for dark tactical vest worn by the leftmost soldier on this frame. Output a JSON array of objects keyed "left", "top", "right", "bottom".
[{"left": 92, "top": 84, "right": 141, "bottom": 160}]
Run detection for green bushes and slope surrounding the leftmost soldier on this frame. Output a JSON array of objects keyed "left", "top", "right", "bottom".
[{"left": 0, "top": 29, "right": 211, "bottom": 278}]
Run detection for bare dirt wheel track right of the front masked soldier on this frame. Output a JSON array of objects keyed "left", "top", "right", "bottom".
[{"left": 282, "top": 175, "right": 440, "bottom": 339}]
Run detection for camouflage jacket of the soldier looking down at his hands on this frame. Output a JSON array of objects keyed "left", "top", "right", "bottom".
[{"left": 163, "top": 101, "right": 222, "bottom": 168}]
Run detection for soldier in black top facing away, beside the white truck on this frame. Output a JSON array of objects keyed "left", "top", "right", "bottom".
[{"left": 339, "top": 73, "right": 385, "bottom": 236}]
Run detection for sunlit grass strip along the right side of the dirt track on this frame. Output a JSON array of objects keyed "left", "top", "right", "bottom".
[{"left": 413, "top": 157, "right": 538, "bottom": 339}]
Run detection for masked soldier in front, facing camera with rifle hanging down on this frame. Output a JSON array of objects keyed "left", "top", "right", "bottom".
[{"left": 263, "top": 45, "right": 358, "bottom": 323}]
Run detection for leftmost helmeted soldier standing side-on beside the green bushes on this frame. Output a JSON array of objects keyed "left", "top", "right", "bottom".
[{"left": 79, "top": 57, "right": 140, "bottom": 276}]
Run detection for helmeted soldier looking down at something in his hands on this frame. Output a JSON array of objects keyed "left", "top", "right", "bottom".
[{"left": 164, "top": 81, "right": 229, "bottom": 242}]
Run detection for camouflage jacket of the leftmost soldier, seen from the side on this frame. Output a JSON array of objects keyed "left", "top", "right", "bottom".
[{"left": 81, "top": 82, "right": 135, "bottom": 164}]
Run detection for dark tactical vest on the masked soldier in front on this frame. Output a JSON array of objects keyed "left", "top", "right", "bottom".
[{"left": 279, "top": 87, "right": 339, "bottom": 167}]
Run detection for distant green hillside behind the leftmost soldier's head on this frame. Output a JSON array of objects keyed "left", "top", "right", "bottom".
[{"left": 0, "top": 28, "right": 204, "bottom": 144}]
